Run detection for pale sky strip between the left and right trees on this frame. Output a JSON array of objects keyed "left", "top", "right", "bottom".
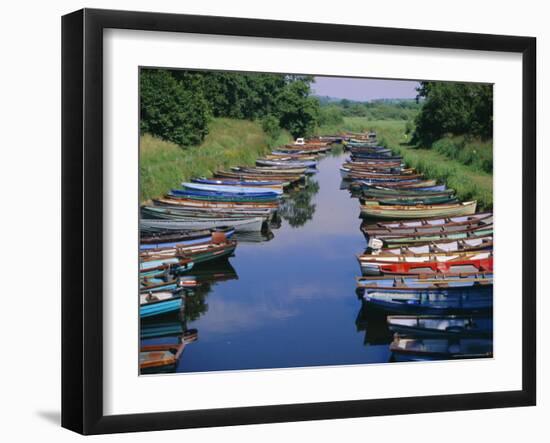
[{"left": 311, "top": 77, "right": 419, "bottom": 101}]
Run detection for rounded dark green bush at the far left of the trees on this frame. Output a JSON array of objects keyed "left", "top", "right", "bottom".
[{"left": 140, "top": 69, "right": 209, "bottom": 146}]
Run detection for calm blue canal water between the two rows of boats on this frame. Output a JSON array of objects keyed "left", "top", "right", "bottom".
[{"left": 143, "top": 151, "right": 391, "bottom": 372}]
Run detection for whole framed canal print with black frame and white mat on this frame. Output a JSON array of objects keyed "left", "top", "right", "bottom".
[{"left": 62, "top": 9, "right": 536, "bottom": 434}]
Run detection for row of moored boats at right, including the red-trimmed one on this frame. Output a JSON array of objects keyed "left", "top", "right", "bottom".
[{"left": 341, "top": 133, "right": 493, "bottom": 361}]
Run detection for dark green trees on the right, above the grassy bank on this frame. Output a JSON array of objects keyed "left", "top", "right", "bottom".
[{"left": 413, "top": 82, "right": 493, "bottom": 146}]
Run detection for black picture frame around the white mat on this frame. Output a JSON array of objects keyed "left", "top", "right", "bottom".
[{"left": 62, "top": 9, "right": 536, "bottom": 434}]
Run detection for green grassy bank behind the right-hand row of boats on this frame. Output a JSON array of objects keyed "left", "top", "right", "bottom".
[{"left": 320, "top": 118, "right": 493, "bottom": 209}]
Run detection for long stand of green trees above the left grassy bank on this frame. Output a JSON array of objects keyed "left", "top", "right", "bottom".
[{"left": 140, "top": 69, "right": 319, "bottom": 146}]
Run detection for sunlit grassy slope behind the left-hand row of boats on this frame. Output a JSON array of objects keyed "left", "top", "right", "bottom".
[{"left": 139, "top": 118, "right": 292, "bottom": 202}]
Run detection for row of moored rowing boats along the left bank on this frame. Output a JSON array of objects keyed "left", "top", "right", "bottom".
[{"left": 139, "top": 138, "right": 334, "bottom": 373}]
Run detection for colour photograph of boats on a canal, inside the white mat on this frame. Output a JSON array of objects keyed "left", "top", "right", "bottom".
[{"left": 136, "top": 66, "right": 494, "bottom": 375}]
